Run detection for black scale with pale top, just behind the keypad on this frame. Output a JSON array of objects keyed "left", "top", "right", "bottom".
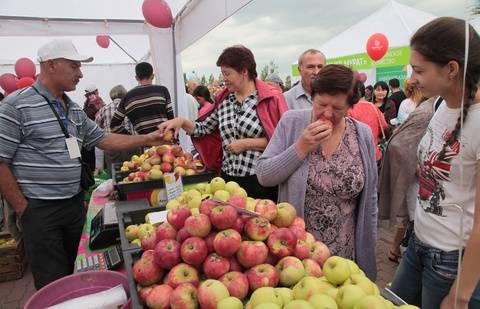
[{"left": 89, "top": 201, "right": 120, "bottom": 250}]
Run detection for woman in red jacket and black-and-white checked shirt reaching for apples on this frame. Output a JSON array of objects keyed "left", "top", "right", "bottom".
[{"left": 159, "top": 45, "right": 288, "bottom": 201}]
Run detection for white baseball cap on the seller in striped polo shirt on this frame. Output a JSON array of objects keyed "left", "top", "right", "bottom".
[{"left": 37, "top": 39, "right": 93, "bottom": 62}]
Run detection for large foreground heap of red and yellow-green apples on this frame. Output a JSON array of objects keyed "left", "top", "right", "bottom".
[{"left": 125, "top": 177, "right": 418, "bottom": 309}]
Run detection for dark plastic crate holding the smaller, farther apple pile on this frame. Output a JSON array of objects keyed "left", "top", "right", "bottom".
[{"left": 112, "top": 164, "right": 215, "bottom": 201}]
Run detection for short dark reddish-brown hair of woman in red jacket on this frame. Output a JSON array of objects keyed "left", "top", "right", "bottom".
[{"left": 217, "top": 45, "right": 257, "bottom": 80}]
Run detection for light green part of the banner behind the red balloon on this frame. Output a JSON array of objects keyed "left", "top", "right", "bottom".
[{"left": 292, "top": 46, "right": 410, "bottom": 76}]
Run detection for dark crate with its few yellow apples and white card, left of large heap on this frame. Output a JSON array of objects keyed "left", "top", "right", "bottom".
[{"left": 116, "top": 201, "right": 166, "bottom": 251}]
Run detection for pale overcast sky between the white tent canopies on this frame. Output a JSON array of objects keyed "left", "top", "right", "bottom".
[{"left": 182, "top": 0, "right": 468, "bottom": 80}]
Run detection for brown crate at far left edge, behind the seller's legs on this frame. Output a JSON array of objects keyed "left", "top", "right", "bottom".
[{"left": 0, "top": 232, "right": 26, "bottom": 282}]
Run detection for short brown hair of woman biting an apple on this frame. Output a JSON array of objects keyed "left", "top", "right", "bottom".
[{"left": 312, "top": 64, "right": 361, "bottom": 106}]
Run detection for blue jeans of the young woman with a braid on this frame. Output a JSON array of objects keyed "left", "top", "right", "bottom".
[{"left": 392, "top": 233, "right": 480, "bottom": 309}]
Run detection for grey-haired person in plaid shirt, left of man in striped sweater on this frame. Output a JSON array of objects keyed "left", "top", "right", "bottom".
[{"left": 95, "top": 85, "right": 141, "bottom": 175}]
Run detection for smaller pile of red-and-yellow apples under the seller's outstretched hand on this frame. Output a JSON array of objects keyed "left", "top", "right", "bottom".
[{"left": 120, "top": 144, "right": 205, "bottom": 183}]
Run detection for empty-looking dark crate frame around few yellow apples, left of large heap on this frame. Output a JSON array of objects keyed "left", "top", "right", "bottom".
[{"left": 116, "top": 201, "right": 166, "bottom": 252}]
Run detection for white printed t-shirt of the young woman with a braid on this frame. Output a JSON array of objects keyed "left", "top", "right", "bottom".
[{"left": 415, "top": 103, "right": 480, "bottom": 251}]
